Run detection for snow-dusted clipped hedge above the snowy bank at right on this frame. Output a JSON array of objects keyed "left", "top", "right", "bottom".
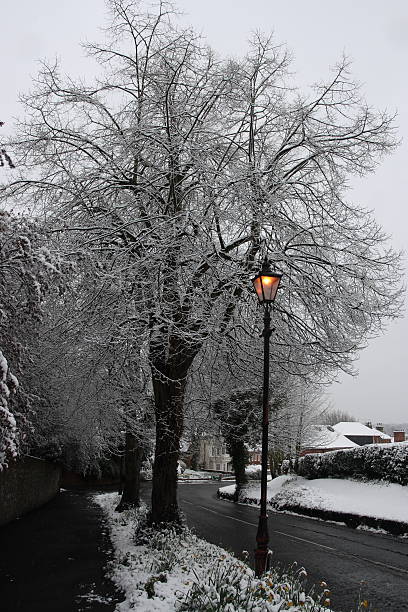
[{"left": 298, "top": 442, "right": 408, "bottom": 485}]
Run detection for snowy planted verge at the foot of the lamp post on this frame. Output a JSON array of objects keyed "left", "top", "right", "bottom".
[{"left": 95, "top": 493, "right": 338, "bottom": 612}]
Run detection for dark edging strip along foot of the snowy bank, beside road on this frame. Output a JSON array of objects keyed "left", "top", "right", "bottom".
[{"left": 217, "top": 489, "right": 408, "bottom": 536}]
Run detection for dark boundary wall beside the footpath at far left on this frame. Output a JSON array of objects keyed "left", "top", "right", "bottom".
[{"left": 0, "top": 457, "right": 61, "bottom": 525}]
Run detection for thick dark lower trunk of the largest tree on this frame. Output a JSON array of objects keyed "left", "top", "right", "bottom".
[{"left": 150, "top": 374, "right": 186, "bottom": 525}]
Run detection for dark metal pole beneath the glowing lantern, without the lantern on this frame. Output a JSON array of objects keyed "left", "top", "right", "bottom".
[{"left": 255, "top": 304, "right": 271, "bottom": 576}]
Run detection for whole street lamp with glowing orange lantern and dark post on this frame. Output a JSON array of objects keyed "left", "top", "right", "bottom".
[{"left": 252, "top": 257, "right": 282, "bottom": 576}]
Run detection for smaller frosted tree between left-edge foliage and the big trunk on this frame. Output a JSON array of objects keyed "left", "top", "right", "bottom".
[{"left": 27, "top": 241, "right": 151, "bottom": 488}]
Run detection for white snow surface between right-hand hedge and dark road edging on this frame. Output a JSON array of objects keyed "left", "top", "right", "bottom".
[{"left": 220, "top": 475, "right": 408, "bottom": 523}]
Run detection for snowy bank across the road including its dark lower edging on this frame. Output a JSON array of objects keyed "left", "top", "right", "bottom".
[{"left": 219, "top": 475, "right": 408, "bottom": 535}]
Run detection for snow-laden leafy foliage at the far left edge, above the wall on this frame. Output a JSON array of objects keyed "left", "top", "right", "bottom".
[{"left": 0, "top": 211, "right": 60, "bottom": 465}]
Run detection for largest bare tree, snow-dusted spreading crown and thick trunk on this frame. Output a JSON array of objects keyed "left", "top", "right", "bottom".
[{"left": 3, "top": 0, "right": 400, "bottom": 523}]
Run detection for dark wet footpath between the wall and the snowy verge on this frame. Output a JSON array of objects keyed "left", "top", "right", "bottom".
[{"left": 0, "top": 491, "right": 123, "bottom": 612}]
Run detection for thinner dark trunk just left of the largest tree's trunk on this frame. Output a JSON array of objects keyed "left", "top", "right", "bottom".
[{"left": 116, "top": 431, "right": 143, "bottom": 512}]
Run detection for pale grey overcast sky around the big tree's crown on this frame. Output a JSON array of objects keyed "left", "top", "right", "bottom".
[{"left": 0, "top": 0, "right": 408, "bottom": 422}]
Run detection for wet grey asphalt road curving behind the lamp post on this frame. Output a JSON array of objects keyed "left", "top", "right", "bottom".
[{"left": 150, "top": 483, "right": 408, "bottom": 612}]
